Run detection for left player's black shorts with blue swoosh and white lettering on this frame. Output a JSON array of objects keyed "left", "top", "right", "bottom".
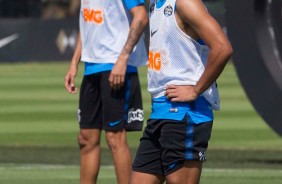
[{"left": 78, "top": 71, "right": 144, "bottom": 131}]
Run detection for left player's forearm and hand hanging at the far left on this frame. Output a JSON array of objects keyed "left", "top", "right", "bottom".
[{"left": 65, "top": 33, "right": 82, "bottom": 94}]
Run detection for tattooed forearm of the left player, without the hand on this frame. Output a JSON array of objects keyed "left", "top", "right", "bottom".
[{"left": 120, "top": 6, "right": 148, "bottom": 61}]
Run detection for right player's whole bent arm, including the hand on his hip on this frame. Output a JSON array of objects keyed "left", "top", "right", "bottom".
[{"left": 166, "top": 0, "right": 233, "bottom": 102}]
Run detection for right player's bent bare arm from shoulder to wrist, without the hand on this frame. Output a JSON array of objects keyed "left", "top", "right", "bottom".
[{"left": 180, "top": 0, "right": 232, "bottom": 94}]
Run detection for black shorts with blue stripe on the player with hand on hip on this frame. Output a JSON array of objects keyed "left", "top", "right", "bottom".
[{"left": 133, "top": 116, "right": 213, "bottom": 176}]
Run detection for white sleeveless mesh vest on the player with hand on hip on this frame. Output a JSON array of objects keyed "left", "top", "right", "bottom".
[{"left": 147, "top": 0, "right": 220, "bottom": 110}]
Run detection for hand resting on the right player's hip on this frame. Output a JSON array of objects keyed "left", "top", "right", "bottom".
[{"left": 165, "top": 85, "right": 198, "bottom": 102}]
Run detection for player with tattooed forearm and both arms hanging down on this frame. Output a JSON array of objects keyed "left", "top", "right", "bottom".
[{"left": 65, "top": 0, "right": 148, "bottom": 184}]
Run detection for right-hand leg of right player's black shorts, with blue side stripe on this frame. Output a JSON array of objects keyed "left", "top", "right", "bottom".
[{"left": 160, "top": 116, "right": 212, "bottom": 176}]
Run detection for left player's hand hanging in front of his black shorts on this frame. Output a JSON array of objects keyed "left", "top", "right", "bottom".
[{"left": 109, "top": 61, "right": 126, "bottom": 90}]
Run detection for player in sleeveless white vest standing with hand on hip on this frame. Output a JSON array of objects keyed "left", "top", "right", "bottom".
[{"left": 130, "top": 0, "right": 232, "bottom": 184}]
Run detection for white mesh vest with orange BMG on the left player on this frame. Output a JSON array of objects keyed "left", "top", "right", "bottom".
[{"left": 80, "top": 0, "right": 147, "bottom": 66}]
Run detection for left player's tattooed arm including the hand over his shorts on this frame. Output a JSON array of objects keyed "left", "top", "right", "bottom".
[{"left": 109, "top": 4, "right": 148, "bottom": 89}]
